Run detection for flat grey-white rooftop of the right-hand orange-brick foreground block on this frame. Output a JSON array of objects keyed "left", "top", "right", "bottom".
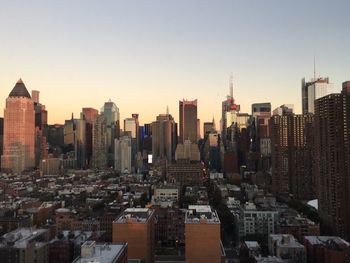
[{"left": 185, "top": 205, "right": 220, "bottom": 224}]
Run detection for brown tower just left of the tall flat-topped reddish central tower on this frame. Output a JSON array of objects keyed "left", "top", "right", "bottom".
[{"left": 152, "top": 114, "right": 177, "bottom": 162}]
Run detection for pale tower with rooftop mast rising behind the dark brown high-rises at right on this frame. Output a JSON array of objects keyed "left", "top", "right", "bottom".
[{"left": 301, "top": 77, "right": 333, "bottom": 114}]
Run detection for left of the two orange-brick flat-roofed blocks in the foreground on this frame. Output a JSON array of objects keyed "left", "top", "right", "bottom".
[{"left": 112, "top": 208, "right": 155, "bottom": 263}]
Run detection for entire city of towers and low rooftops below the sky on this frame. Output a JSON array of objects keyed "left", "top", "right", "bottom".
[{"left": 0, "top": 77, "right": 350, "bottom": 263}]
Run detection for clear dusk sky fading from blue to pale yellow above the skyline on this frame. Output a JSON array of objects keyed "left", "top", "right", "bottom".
[{"left": 0, "top": 0, "right": 350, "bottom": 130}]
